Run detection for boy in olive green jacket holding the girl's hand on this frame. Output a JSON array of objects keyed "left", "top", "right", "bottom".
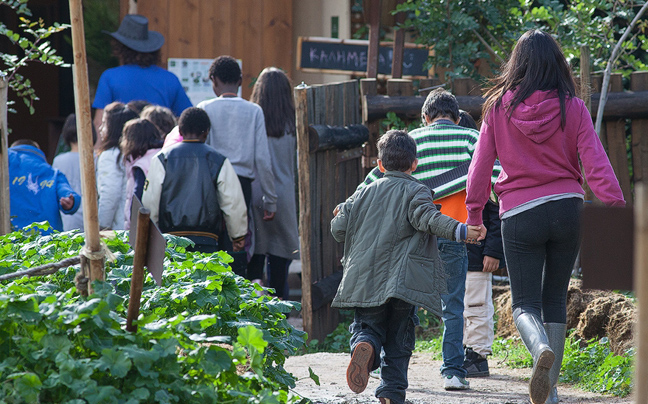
[{"left": 331, "top": 130, "right": 485, "bottom": 404}]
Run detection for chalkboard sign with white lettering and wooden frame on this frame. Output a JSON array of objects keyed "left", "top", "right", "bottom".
[{"left": 297, "top": 37, "right": 429, "bottom": 77}]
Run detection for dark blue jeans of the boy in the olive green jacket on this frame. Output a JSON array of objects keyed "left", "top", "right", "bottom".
[{"left": 349, "top": 299, "right": 419, "bottom": 404}]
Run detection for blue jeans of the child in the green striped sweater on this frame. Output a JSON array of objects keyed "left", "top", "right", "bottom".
[{"left": 438, "top": 237, "right": 468, "bottom": 378}]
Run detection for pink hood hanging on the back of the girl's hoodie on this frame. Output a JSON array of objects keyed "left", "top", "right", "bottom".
[{"left": 502, "top": 91, "right": 561, "bottom": 143}]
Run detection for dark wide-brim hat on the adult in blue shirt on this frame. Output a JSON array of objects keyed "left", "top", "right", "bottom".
[{"left": 103, "top": 14, "right": 164, "bottom": 53}]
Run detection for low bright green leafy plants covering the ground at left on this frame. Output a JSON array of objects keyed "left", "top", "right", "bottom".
[{"left": 0, "top": 224, "right": 305, "bottom": 403}]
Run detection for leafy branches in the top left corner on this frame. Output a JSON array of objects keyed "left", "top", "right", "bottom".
[{"left": 0, "top": 0, "right": 69, "bottom": 114}]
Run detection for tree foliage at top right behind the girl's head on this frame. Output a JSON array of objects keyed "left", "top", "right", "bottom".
[{"left": 395, "top": 0, "right": 648, "bottom": 77}]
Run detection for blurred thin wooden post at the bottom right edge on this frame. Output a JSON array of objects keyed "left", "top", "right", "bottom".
[{"left": 634, "top": 183, "right": 648, "bottom": 404}]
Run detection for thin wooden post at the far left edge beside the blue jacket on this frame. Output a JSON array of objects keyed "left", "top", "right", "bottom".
[{"left": 0, "top": 79, "right": 11, "bottom": 236}]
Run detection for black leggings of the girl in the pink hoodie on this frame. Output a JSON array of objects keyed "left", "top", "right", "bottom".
[{"left": 502, "top": 198, "right": 583, "bottom": 324}]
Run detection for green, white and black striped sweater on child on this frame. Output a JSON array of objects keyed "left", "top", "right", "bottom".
[{"left": 358, "top": 119, "right": 501, "bottom": 200}]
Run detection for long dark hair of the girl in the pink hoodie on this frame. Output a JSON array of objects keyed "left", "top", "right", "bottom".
[{"left": 482, "top": 29, "right": 576, "bottom": 128}]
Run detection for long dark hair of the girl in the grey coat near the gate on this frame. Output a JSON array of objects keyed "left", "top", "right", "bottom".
[{"left": 250, "top": 67, "right": 295, "bottom": 137}]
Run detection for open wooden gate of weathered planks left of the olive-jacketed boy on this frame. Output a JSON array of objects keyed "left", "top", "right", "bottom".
[{"left": 295, "top": 81, "right": 364, "bottom": 341}]
